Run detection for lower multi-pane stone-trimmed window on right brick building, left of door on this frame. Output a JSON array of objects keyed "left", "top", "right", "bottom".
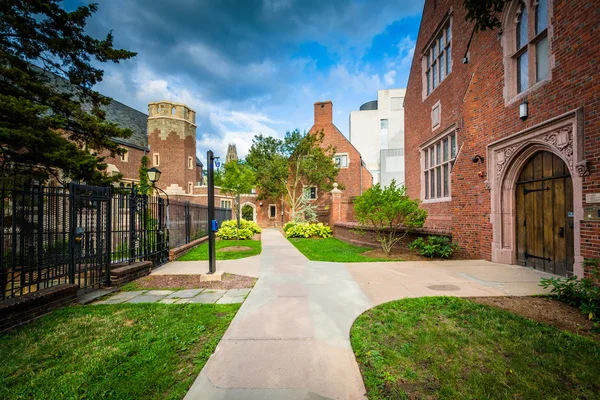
[{"left": 422, "top": 131, "right": 456, "bottom": 200}]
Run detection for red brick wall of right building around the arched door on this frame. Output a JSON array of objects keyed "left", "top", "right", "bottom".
[{"left": 405, "top": 0, "right": 600, "bottom": 268}]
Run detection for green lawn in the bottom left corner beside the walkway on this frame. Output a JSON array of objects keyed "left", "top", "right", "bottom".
[{"left": 0, "top": 304, "right": 239, "bottom": 399}]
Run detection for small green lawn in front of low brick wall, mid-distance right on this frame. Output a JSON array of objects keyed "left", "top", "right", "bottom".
[{"left": 288, "top": 237, "right": 402, "bottom": 262}]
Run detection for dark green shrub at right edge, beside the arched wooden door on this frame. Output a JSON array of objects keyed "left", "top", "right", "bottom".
[{"left": 540, "top": 259, "right": 600, "bottom": 321}]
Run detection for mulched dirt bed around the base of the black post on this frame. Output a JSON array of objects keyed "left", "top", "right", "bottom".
[{"left": 129, "top": 273, "right": 257, "bottom": 290}]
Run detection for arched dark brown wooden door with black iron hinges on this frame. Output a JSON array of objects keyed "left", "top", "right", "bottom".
[{"left": 516, "top": 151, "right": 574, "bottom": 275}]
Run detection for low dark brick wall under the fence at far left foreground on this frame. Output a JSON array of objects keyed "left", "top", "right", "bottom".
[{"left": 0, "top": 284, "right": 79, "bottom": 332}]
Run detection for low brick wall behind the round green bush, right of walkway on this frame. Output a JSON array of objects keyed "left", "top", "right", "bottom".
[{"left": 333, "top": 222, "right": 452, "bottom": 248}]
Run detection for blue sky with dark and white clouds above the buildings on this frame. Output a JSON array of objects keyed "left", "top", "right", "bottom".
[{"left": 65, "top": 0, "right": 423, "bottom": 160}]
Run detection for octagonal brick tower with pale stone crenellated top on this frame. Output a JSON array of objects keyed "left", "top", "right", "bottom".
[{"left": 148, "top": 100, "right": 198, "bottom": 194}]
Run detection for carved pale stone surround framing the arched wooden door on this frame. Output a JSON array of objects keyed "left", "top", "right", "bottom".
[{"left": 486, "top": 110, "right": 589, "bottom": 276}]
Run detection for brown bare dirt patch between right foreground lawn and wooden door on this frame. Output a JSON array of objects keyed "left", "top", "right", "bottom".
[{"left": 468, "top": 296, "right": 600, "bottom": 341}]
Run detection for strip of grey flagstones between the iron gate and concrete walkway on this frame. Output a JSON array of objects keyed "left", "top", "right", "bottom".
[{"left": 94, "top": 289, "right": 252, "bottom": 304}]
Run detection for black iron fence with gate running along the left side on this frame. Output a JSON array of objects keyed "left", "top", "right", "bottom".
[{"left": 0, "top": 181, "right": 231, "bottom": 300}]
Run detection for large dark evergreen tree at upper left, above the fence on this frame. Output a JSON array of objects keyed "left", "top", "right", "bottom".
[{"left": 0, "top": 0, "right": 135, "bottom": 184}]
